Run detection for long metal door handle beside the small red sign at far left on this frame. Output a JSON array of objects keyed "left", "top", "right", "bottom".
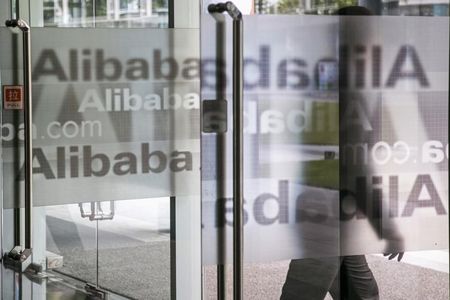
[{"left": 5, "top": 19, "right": 33, "bottom": 271}]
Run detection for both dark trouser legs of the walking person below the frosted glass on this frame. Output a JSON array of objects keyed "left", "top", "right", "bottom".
[{"left": 280, "top": 255, "right": 379, "bottom": 300}]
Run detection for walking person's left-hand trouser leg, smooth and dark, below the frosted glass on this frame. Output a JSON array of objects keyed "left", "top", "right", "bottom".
[{"left": 280, "top": 257, "right": 340, "bottom": 300}]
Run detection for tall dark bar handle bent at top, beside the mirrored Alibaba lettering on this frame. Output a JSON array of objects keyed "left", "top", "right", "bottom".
[{"left": 208, "top": 2, "right": 244, "bottom": 300}]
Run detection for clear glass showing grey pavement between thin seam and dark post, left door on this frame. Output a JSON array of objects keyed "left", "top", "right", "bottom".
[{"left": 98, "top": 198, "right": 171, "bottom": 299}]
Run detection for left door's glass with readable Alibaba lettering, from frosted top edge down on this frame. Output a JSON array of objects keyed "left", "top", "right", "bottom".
[{"left": 25, "top": 28, "right": 200, "bottom": 299}]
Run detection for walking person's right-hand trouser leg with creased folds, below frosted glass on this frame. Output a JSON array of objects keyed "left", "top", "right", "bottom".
[{"left": 340, "top": 255, "right": 379, "bottom": 300}]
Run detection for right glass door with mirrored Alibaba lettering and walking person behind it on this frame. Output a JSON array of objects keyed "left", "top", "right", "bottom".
[{"left": 201, "top": 1, "right": 449, "bottom": 299}]
